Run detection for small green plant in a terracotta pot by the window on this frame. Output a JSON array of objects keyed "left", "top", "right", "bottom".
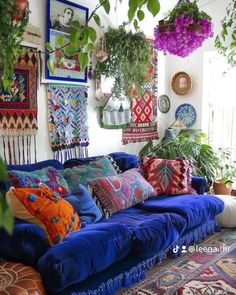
[{"left": 213, "top": 148, "right": 236, "bottom": 195}]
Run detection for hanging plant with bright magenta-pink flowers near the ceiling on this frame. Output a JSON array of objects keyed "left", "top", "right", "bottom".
[{"left": 154, "top": 0, "right": 213, "bottom": 57}]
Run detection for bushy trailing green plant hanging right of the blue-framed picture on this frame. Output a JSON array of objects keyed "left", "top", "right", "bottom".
[{"left": 94, "top": 25, "right": 152, "bottom": 97}]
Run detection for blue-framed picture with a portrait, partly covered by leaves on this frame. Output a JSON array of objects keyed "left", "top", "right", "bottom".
[{"left": 45, "top": 0, "right": 88, "bottom": 82}]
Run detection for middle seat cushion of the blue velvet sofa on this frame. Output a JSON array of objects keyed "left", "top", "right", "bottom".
[{"left": 108, "top": 208, "right": 186, "bottom": 258}]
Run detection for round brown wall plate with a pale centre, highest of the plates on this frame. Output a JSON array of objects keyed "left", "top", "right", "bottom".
[{"left": 171, "top": 72, "right": 192, "bottom": 95}]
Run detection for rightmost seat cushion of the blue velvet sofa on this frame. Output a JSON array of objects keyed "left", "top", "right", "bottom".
[{"left": 138, "top": 195, "right": 224, "bottom": 229}]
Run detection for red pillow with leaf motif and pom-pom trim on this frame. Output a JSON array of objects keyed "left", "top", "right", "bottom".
[{"left": 141, "top": 157, "right": 195, "bottom": 195}]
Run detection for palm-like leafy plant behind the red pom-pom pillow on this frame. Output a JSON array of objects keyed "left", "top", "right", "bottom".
[{"left": 140, "top": 132, "right": 218, "bottom": 183}]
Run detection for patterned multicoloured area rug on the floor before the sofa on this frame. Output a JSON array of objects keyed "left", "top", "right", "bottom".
[{"left": 119, "top": 229, "right": 236, "bottom": 295}]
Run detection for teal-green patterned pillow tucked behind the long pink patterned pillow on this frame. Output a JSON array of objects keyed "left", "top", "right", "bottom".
[{"left": 63, "top": 156, "right": 117, "bottom": 191}]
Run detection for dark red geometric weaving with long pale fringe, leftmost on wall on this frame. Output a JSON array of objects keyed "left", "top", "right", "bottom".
[{"left": 0, "top": 47, "right": 38, "bottom": 164}]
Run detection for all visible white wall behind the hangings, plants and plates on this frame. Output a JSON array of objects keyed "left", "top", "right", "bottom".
[{"left": 12, "top": 0, "right": 227, "bottom": 160}]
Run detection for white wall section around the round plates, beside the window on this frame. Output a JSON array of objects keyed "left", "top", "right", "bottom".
[{"left": 162, "top": 0, "right": 230, "bottom": 129}]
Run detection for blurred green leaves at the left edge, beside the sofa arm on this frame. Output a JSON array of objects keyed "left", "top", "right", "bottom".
[{"left": 0, "top": 158, "right": 14, "bottom": 234}]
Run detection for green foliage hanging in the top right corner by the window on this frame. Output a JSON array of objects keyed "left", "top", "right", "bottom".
[{"left": 215, "top": 0, "right": 236, "bottom": 66}]
